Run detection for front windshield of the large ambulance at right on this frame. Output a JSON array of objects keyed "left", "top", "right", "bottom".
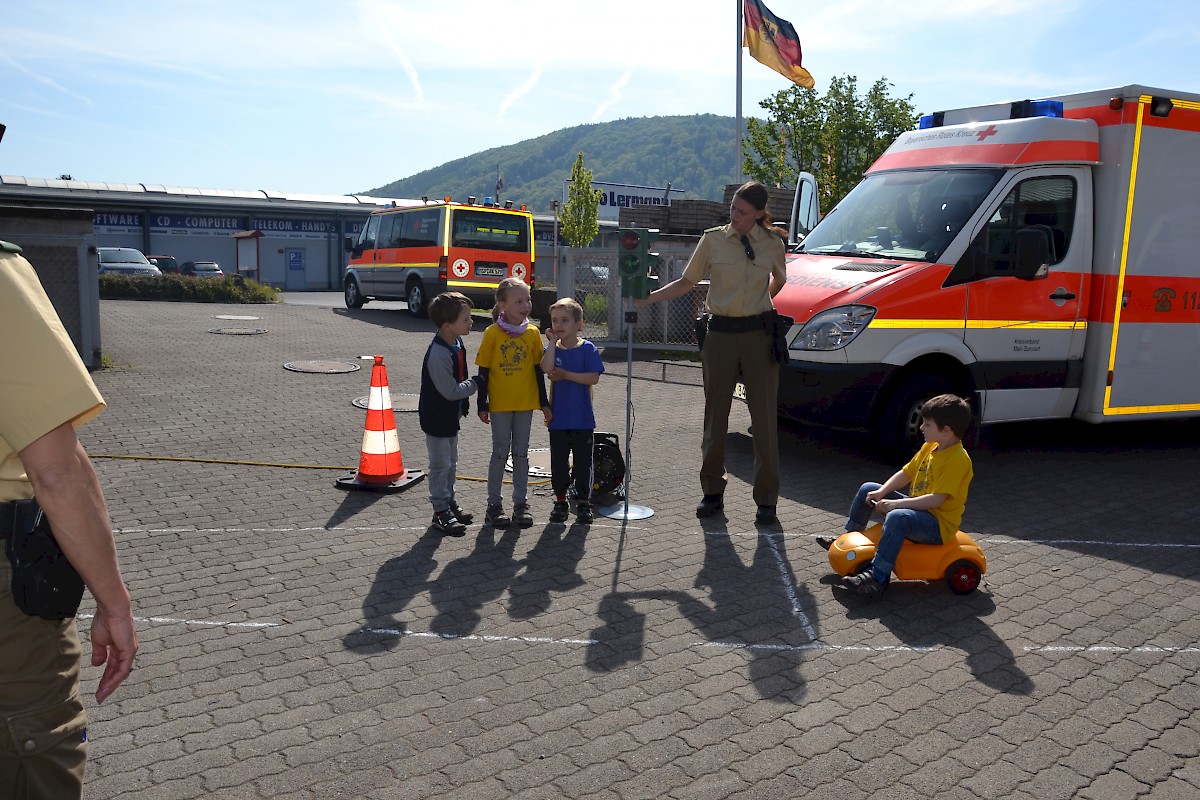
[{"left": 800, "top": 169, "right": 1004, "bottom": 261}]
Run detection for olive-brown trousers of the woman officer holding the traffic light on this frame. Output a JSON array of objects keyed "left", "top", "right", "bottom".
[{"left": 700, "top": 330, "right": 779, "bottom": 506}]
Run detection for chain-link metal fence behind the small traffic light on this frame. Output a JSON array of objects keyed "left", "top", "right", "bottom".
[{"left": 558, "top": 237, "right": 708, "bottom": 351}]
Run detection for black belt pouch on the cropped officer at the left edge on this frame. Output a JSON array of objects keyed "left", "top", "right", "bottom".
[{"left": 5, "top": 500, "right": 83, "bottom": 619}]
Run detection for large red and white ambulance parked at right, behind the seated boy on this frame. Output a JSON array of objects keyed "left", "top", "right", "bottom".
[{"left": 775, "top": 85, "right": 1200, "bottom": 457}]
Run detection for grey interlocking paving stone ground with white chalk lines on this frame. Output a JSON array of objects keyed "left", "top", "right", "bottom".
[{"left": 80, "top": 301, "right": 1200, "bottom": 800}]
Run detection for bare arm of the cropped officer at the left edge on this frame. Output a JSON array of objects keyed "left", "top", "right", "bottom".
[{"left": 19, "top": 422, "right": 138, "bottom": 703}]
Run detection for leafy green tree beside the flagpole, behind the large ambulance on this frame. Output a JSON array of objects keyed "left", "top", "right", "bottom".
[{"left": 743, "top": 76, "right": 917, "bottom": 210}]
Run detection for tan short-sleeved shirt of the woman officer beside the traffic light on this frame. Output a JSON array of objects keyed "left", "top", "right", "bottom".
[{"left": 683, "top": 223, "right": 787, "bottom": 317}]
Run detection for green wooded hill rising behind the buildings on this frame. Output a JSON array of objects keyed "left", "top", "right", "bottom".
[{"left": 362, "top": 114, "right": 737, "bottom": 213}]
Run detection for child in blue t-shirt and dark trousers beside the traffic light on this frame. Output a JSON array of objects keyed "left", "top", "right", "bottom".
[{"left": 541, "top": 297, "right": 604, "bottom": 524}]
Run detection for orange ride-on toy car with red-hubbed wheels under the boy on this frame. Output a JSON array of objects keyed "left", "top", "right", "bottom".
[{"left": 829, "top": 523, "right": 988, "bottom": 595}]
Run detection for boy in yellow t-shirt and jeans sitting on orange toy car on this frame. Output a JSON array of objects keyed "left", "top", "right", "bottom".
[{"left": 817, "top": 395, "right": 974, "bottom": 596}]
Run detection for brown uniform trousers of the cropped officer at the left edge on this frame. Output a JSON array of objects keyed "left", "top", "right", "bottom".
[{"left": 0, "top": 556, "right": 88, "bottom": 800}]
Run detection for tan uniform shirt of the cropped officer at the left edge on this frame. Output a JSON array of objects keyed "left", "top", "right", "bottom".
[{"left": 0, "top": 252, "right": 104, "bottom": 501}]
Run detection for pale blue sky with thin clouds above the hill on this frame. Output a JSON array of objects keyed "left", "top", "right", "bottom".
[{"left": 0, "top": 0, "right": 1200, "bottom": 194}]
